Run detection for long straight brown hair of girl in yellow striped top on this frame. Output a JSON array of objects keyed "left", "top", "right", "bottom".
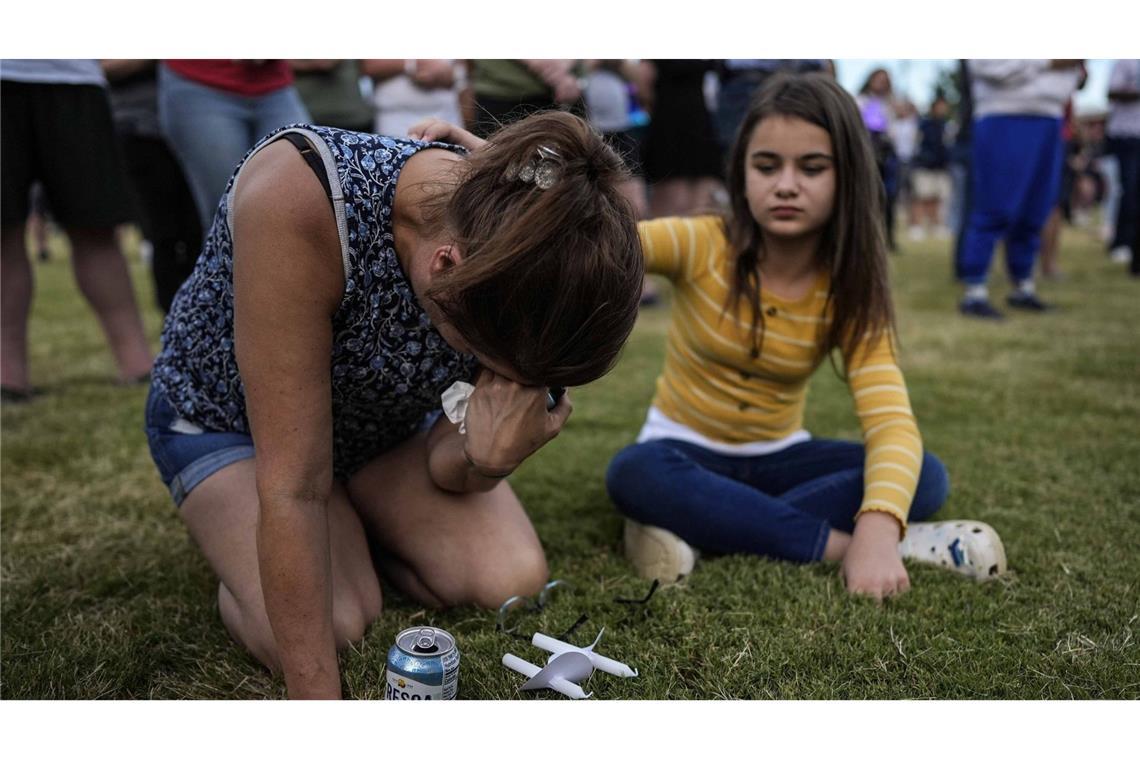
[{"left": 725, "top": 73, "right": 895, "bottom": 359}]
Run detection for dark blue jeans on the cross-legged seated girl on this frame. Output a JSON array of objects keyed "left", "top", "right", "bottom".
[{"left": 605, "top": 440, "right": 950, "bottom": 562}]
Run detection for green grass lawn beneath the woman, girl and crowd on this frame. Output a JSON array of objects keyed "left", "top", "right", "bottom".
[{"left": 0, "top": 230, "right": 1140, "bottom": 700}]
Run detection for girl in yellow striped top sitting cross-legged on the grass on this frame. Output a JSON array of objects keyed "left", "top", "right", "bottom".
[{"left": 606, "top": 74, "right": 1005, "bottom": 597}]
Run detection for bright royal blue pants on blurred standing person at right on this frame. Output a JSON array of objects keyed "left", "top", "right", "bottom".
[{"left": 959, "top": 116, "right": 1064, "bottom": 285}]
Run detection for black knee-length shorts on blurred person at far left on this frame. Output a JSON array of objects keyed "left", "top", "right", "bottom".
[{"left": 0, "top": 80, "right": 133, "bottom": 228}]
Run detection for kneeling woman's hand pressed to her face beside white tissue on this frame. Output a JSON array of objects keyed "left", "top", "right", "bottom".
[{"left": 464, "top": 369, "right": 573, "bottom": 473}]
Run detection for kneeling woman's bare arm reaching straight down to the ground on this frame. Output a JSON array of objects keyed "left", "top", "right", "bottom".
[{"left": 226, "top": 142, "right": 344, "bottom": 698}]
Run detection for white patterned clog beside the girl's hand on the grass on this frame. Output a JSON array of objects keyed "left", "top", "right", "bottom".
[{"left": 898, "top": 520, "right": 1007, "bottom": 581}]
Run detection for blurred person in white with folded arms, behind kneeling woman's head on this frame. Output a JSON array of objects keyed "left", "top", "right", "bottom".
[{"left": 360, "top": 58, "right": 467, "bottom": 137}]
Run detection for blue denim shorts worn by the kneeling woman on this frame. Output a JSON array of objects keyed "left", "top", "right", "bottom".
[{"left": 146, "top": 385, "right": 253, "bottom": 507}]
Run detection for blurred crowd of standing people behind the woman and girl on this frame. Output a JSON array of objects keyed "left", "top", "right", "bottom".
[{"left": 0, "top": 59, "right": 1140, "bottom": 400}]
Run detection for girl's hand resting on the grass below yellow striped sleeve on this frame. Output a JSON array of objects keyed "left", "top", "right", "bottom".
[{"left": 839, "top": 512, "right": 911, "bottom": 599}]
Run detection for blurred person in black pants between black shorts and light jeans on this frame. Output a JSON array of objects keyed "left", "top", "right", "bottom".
[{"left": 101, "top": 59, "right": 202, "bottom": 313}]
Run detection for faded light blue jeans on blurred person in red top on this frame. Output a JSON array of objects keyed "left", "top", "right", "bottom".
[{"left": 158, "top": 66, "right": 309, "bottom": 230}]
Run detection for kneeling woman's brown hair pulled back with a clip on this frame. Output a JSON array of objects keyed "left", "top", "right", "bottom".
[{"left": 428, "top": 112, "right": 645, "bottom": 385}]
